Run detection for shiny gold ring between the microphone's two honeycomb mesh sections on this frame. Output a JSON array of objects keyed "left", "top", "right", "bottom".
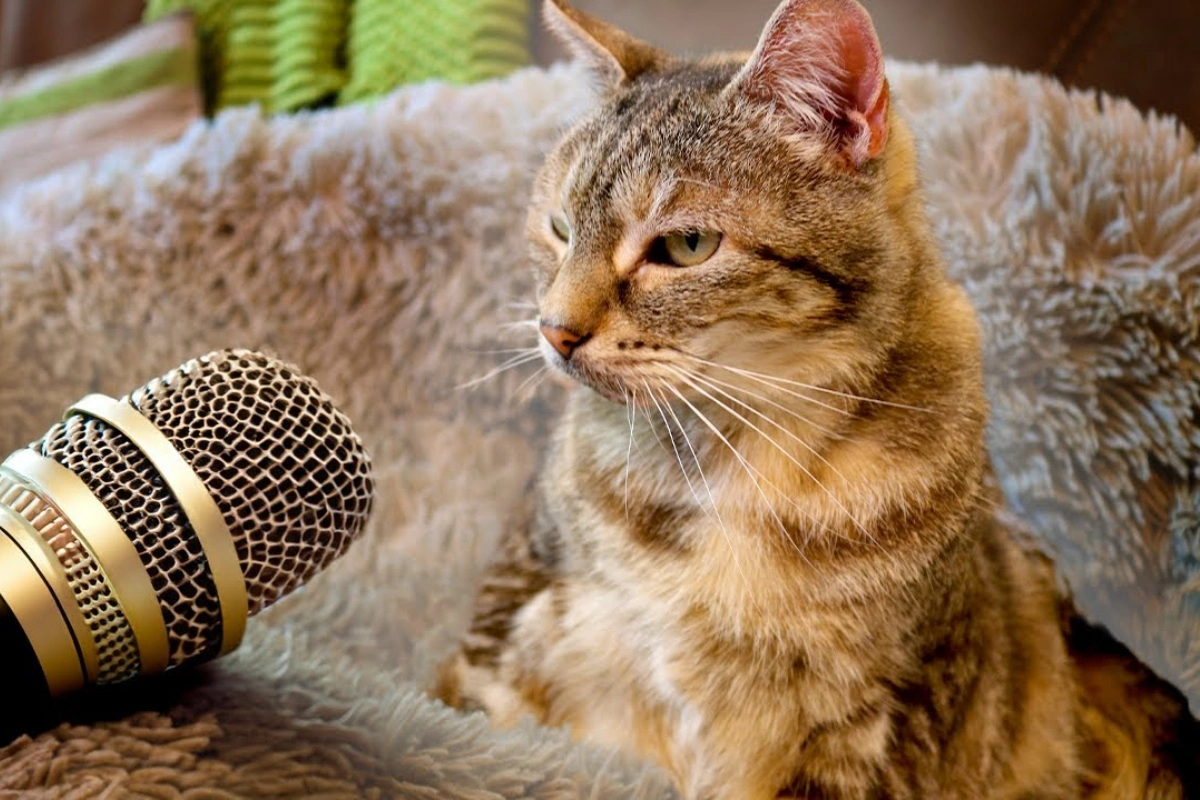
[{"left": 64, "top": 395, "right": 250, "bottom": 654}]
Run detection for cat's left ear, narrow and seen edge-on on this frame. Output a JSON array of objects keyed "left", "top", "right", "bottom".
[{"left": 542, "top": 0, "right": 670, "bottom": 89}]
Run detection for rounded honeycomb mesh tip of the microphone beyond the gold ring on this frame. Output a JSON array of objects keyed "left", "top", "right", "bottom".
[{"left": 127, "top": 350, "right": 374, "bottom": 614}]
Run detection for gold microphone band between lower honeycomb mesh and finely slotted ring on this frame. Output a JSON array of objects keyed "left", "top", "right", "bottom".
[{"left": 2, "top": 449, "right": 169, "bottom": 675}]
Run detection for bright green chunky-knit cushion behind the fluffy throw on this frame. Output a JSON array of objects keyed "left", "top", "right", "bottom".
[{"left": 146, "top": 0, "right": 529, "bottom": 112}]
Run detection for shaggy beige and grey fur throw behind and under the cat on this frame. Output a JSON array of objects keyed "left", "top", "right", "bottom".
[{"left": 0, "top": 64, "right": 1200, "bottom": 800}]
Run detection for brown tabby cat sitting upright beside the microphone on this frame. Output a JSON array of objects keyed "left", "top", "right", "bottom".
[{"left": 437, "top": 0, "right": 1193, "bottom": 800}]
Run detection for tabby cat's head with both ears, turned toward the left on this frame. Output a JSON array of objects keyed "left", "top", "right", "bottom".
[{"left": 528, "top": 0, "right": 926, "bottom": 401}]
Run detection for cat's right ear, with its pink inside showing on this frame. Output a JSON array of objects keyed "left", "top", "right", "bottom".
[{"left": 728, "top": 0, "right": 888, "bottom": 167}]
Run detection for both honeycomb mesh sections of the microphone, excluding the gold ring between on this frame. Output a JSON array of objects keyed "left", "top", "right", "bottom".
[{"left": 38, "top": 350, "right": 374, "bottom": 666}]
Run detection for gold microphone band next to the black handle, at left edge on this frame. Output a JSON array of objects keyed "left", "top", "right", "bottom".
[{"left": 0, "top": 506, "right": 86, "bottom": 697}]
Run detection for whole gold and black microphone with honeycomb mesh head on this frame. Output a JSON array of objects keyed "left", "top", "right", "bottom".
[{"left": 0, "top": 350, "right": 374, "bottom": 722}]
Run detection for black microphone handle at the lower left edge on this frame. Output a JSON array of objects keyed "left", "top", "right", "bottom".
[{"left": 0, "top": 594, "right": 54, "bottom": 747}]
